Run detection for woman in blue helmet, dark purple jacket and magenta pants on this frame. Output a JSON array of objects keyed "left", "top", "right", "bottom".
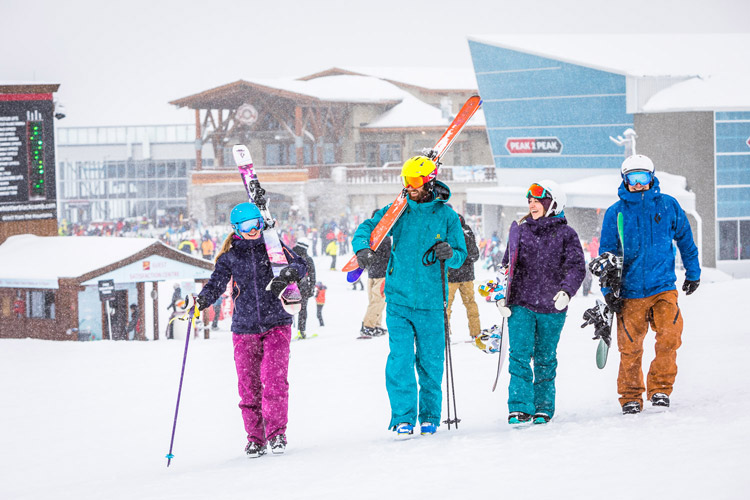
[{"left": 195, "top": 203, "right": 307, "bottom": 458}]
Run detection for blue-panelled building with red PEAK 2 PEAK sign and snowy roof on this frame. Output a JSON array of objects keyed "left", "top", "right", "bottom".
[{"left": 467, "top": 34, "right": 750, "bottom": 277}]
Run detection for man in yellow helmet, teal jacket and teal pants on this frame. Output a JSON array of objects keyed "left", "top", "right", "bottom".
[{"left": 352, "top": 156, "right": 467, "bottom": 438}]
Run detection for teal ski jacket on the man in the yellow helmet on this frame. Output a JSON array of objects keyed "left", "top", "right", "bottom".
[{"left": 352, "top": 181, "right": 466, "bottom": 309}]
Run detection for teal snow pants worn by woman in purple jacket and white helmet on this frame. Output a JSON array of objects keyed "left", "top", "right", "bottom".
[{"left": 508, "top": 306, "right": 565, "bottom": 417}]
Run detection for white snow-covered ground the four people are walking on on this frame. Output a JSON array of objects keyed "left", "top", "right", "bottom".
[{"left": 0, "top": 257, "right": 750, "bottom": 500}]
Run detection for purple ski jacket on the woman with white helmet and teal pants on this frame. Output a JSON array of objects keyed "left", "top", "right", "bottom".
[{"left": 503, "top": 215, "right": 586, "bottom": 314}]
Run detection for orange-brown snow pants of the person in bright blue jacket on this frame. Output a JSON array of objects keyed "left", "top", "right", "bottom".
[{"left": 617, "top": 290, "right": 682, "bottom": 407}]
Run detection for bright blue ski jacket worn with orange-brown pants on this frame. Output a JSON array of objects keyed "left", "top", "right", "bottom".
[{"left": 599, "top": 178, "right": 701, "bottom": 299}]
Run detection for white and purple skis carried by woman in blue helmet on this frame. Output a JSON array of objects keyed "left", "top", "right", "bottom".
[{"left": 232, "top": 144, "right": 302, "bottom": 315}]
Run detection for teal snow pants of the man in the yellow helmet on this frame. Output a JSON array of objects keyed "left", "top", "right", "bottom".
[{"left": 385, "top": 303, "right": 445, "bottom": 429}]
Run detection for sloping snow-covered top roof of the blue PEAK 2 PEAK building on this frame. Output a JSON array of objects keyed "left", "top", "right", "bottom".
[{"left": 469, "top": 33, "right": 750, "bottom": 76}]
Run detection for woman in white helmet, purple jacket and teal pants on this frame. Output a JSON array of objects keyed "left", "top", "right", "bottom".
[{"left": 497, "top": 181, "right": 586, "bottom": 424}]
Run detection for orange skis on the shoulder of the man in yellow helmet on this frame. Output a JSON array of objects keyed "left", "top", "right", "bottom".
[{"left": 341, "top": 95, "right": 482, "bottom": 283}]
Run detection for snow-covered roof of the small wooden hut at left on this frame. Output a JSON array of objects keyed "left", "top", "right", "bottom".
[{"left": 0, "top": 234, "right": 160, "bottom": 288}]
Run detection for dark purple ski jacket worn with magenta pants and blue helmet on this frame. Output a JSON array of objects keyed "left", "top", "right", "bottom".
[{"left": 198, "top": 237, "right": 307, "bottom": 334}]
